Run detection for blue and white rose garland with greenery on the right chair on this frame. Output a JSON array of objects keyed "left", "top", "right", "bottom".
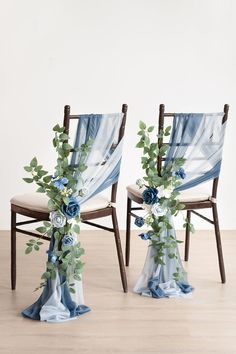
[{"left": 135, "top": 121, "right": 194, "bottom": 280}]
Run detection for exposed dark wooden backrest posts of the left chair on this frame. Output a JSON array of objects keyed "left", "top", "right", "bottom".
[{"left": 63, "top": 104, "right": 128, "bottom": 203}]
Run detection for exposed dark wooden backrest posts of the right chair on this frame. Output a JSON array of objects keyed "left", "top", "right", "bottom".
[{"left": 157, "top": 104, "right": 229, "bottom": 198}]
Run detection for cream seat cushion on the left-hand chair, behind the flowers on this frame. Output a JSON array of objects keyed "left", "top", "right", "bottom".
[{"left": 11, "top": 193, "right": 109, "bottom": 213}]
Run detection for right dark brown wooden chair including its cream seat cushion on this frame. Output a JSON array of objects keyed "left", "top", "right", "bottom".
[{"left": 125, "top": 104, "right": 229, "bottom": 283}]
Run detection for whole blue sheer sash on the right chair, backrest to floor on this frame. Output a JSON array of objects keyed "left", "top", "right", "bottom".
[{"left": 134, "top": 113, "right": 226, "bottom": 298}]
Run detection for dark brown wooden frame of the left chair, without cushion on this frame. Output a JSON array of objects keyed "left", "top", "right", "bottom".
[{"left": 11, "top": 104, "right": 128, "bottom": 292}]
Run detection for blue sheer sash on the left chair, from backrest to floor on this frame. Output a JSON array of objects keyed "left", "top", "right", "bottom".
[{"left": 22, "top": 113, "right": 123, "bottom": 322}]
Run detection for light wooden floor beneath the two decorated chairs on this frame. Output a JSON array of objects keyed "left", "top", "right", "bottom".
[{"left": 0, "top": 231, "right": 236, "bottom": 354}]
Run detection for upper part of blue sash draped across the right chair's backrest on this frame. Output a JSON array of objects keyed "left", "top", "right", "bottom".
[{"left": 166, "top": 113, "right": 226, "bottom": 190}]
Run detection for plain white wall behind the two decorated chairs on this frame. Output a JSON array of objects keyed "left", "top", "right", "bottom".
[{"left": 0, "top": 0, "right": 236, "bottom": 229}]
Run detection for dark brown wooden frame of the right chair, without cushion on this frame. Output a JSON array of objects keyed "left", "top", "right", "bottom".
[{"left": 125, "top": 104, "right": 229, "bottom": 283}]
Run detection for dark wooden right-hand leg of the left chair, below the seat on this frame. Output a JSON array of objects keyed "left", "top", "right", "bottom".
[{"left": 112, "top": 208, "right": 128, "bottom": 293}]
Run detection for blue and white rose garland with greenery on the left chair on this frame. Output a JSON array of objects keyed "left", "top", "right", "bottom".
[{"left": 23, "top": 124, "right": 92, "bottom": 293}]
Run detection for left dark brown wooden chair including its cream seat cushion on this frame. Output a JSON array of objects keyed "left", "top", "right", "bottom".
[{"left": 11, "top": 104, "right": 128, "bottom": 292}]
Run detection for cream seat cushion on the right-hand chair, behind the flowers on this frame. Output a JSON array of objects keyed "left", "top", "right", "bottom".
[{"left": 127, "top": 184, "right": 211, "bottom": 203}]
